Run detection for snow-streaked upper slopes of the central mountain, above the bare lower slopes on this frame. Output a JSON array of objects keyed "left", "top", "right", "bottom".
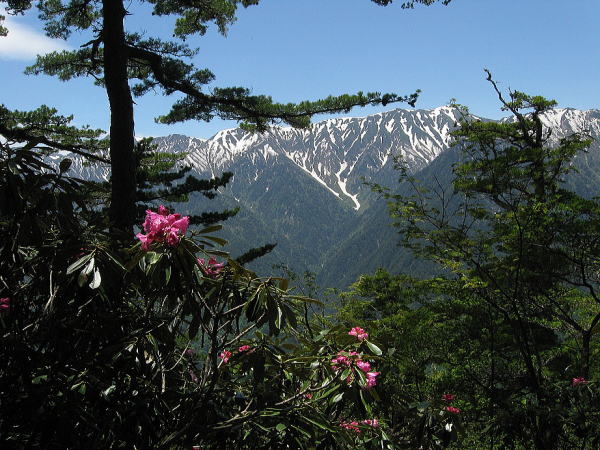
[{"left": 154, "top": 107, "right": 459, "bottom": 210}]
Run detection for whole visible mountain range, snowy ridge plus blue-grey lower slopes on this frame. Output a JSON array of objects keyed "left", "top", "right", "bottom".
[{"left": 54, "top": 107, "right": 600, "bottom": 287}]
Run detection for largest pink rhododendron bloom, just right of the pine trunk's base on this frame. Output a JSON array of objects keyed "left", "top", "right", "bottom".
[{"left": 135, "top": 205, "right": 190, "bottom": 251}]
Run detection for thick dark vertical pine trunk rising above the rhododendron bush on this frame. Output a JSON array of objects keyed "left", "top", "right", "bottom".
[{"left": 102, "top": 0, "right": 136, "bottom": 241}]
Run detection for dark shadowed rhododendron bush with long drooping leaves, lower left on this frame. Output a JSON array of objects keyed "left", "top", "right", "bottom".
[{"left": 0, "top": 104, "right": 398, "bottom": 449}]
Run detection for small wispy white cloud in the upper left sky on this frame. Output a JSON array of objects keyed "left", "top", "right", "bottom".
[{"left": 0, "top": 10, "right": 69, "bottom": 61}]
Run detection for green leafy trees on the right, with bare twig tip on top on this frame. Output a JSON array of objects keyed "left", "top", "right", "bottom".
[{"left": 345, "top": 74, "right": 600, "bottom": 449}]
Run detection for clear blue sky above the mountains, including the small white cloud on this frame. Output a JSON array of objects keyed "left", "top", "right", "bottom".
[{"left": 0, "top": 0, "right": 600, "bottom": 137}]
